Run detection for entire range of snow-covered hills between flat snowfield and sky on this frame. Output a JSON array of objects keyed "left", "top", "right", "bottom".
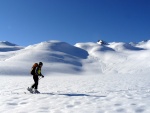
[{"left": 0, "top": 40, "right": 150, "bottom": 75}]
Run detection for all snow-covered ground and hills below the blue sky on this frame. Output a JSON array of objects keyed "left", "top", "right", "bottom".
[{"left": 0, "top": 40, "right": 150, "bottom": 113}]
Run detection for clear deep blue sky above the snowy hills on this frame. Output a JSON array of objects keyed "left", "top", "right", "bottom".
[{"left": 0, "top": 0, "right": 150, "bottom": 46}]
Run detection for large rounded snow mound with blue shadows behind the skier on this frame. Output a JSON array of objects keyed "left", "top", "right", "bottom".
[{"left": 0, "top": 41, "right": 88, "bottom": 75}]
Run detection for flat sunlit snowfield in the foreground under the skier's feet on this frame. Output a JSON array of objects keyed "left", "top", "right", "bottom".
[{"left": 0, "top": 75, "right": 150, "bottom": 113}]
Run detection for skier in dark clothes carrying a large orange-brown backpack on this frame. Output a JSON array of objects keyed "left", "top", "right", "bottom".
[{"left": 28, "top": 62, "right": 44, "bottom": 93}]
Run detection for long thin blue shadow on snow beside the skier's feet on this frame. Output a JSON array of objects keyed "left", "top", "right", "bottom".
[{"left": 40, "top": 93, "right": 106, "bottom": 98}]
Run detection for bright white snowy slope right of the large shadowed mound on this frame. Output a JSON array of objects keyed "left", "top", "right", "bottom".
[{"left": 75, "top": 42, "right": 150, "bottom": 74}]
